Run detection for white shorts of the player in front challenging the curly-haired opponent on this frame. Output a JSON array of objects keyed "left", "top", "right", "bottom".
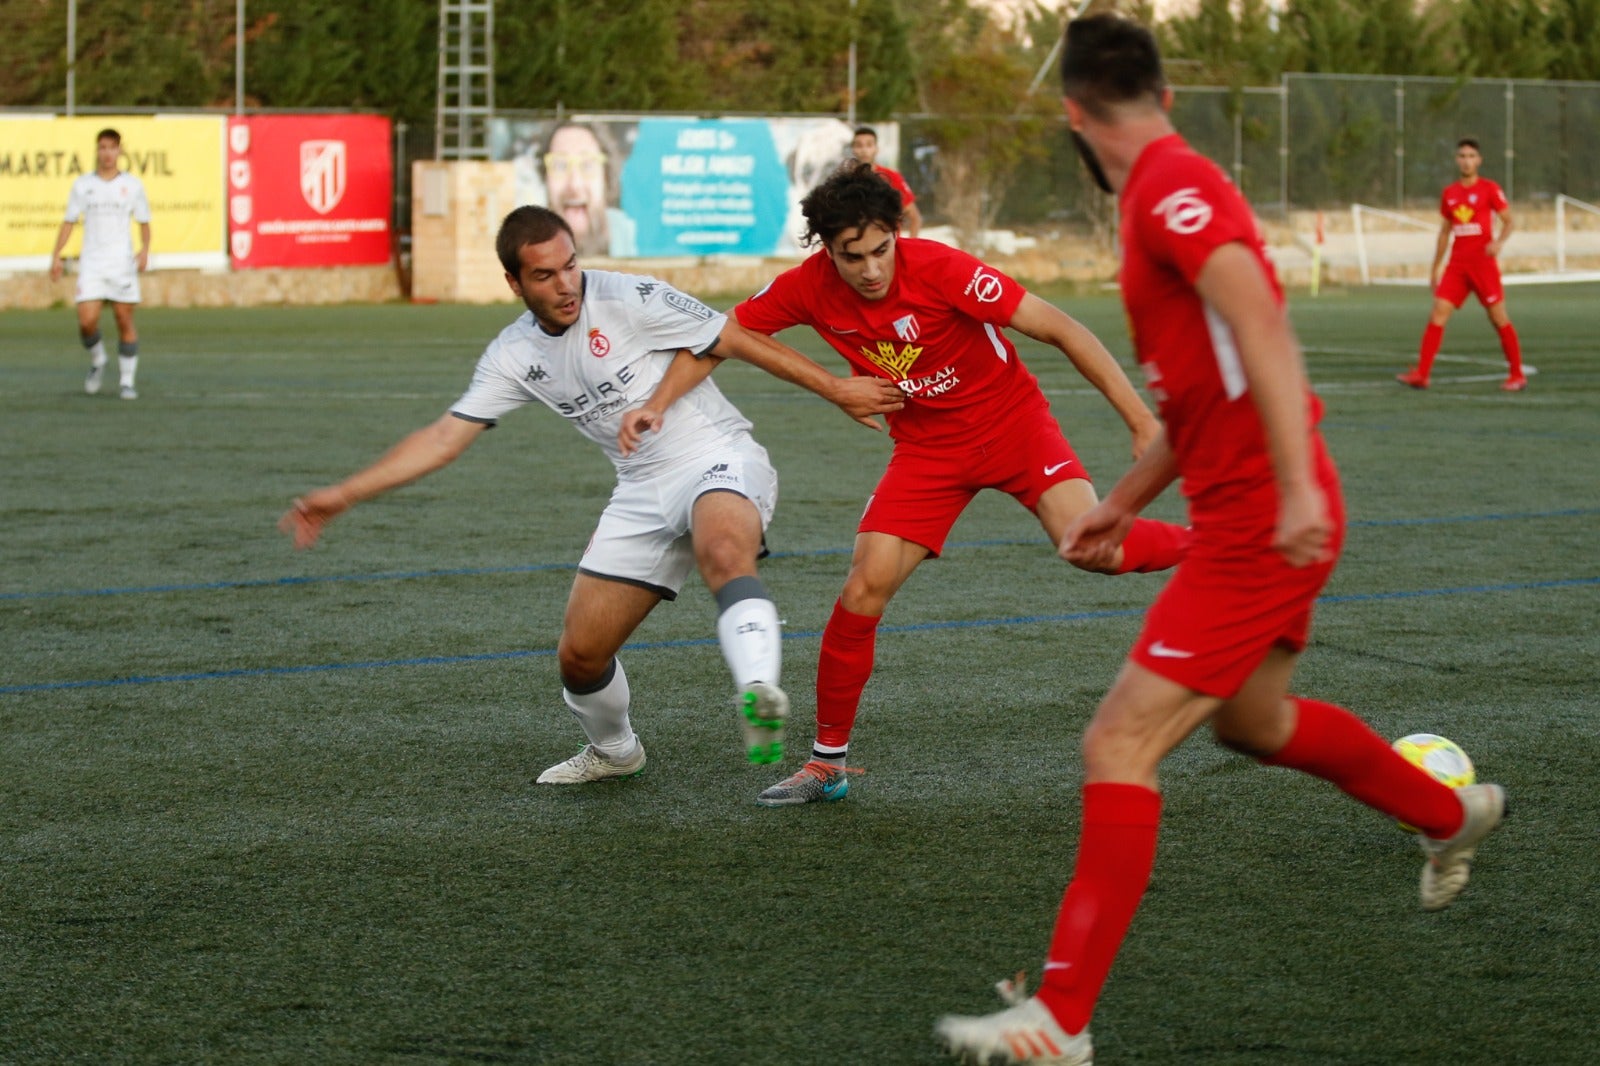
[{"left": 578, "top": 437, "right": 778, "bottom": 600}]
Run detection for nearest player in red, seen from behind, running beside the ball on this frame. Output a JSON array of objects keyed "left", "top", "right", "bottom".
[{"left": 938, "top": 14, "right": 1504, "bottom": 1064}]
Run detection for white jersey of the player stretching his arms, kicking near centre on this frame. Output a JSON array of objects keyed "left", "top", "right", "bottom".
[{"left": 450, "top": 271, "right": 750, "bottom": 480}]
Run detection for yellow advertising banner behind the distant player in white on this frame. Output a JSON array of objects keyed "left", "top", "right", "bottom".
[{"left": 0, "top": 115, "right": 227, "bottom": 269}]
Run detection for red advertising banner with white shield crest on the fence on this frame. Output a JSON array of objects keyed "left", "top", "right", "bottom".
[{"left": 227, "top": 115, "right": 394, "bottom": 271}]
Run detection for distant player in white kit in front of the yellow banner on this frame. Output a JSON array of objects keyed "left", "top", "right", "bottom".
[{"left": 50, "top": 130, "right": 150, "bottom": 400}]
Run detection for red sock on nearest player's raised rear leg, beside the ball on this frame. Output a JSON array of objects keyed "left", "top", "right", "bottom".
[{"left": 1261, "top": 696, "right": 1464, "bottom": 839}]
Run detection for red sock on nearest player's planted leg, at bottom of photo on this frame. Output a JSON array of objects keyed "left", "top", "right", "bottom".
[{"left": 1038, "top": 783, "right": 1162, "bottom": 1032}]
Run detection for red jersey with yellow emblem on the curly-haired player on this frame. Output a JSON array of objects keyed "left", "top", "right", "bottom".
[{"left": 733, "top": 237, "right": 1050, "bottom": 448}]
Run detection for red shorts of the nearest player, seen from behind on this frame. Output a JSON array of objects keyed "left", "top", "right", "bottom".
[{"left": 1128, "top": 453, "right": 1344, "bottom": 699}]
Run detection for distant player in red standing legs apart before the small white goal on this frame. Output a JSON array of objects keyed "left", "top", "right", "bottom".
[{"left": 1395, "top": 138, "right": 1528, "bottom": 392}]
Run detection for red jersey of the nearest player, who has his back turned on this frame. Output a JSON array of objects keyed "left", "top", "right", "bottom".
[{"left": 1122, "top": 134, "right": 1322, "bottom": 517}]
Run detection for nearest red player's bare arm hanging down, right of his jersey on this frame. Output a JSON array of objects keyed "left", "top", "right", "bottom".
[{"left": 1195, "top": 242, "right": 1333, "bottom": 567}]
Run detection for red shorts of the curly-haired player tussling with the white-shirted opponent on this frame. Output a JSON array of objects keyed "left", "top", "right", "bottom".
[{"left": 856, "top": 407, "right": 1088, "bottom": 555}]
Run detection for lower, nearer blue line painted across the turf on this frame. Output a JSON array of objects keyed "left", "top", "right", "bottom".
[{"left": 0, "top": 576, "right": 1600, "bottom": 696}]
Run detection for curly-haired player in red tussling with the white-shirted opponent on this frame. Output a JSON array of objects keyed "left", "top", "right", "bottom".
[{"left": 733, "top": 163, "right": 1186, "bottom": 807}]
